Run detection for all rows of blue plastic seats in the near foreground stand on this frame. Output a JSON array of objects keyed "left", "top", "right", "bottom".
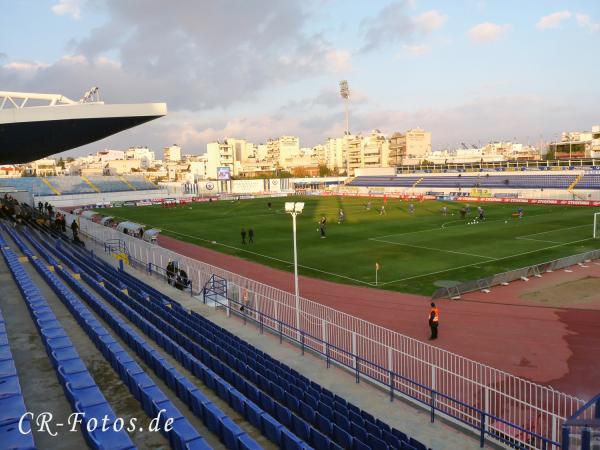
[{"left": 0, "top": 219, "right": 434, "bottom": 450}]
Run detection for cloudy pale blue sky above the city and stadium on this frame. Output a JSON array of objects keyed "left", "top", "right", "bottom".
[{"left": 0, "top": 0, "right": 600, "bottom": 156}]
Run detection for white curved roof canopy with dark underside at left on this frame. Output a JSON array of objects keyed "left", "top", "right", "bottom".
[{"left": 0, "top": 88, "right": 167, "bottom": 164}]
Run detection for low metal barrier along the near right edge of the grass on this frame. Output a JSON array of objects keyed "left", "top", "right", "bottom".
[{"left": 431, "top": 250, "right": 600, "bottom": 300}]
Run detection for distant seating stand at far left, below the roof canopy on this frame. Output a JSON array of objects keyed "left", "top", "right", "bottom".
[{"left": 0, "top": 176, "right": 158, "bottom": 195}]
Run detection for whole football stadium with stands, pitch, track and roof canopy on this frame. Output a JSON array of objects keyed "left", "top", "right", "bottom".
[{"left": 0, "top": 86, "right": 600, "bottom": 450}]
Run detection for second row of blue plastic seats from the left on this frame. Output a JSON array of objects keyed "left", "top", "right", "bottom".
[{"left": 0, "top": 232, "right": 135, "bottom": 450}]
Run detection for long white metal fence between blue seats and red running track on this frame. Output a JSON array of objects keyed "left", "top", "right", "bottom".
[{"left": 67, "top": 215, "right": 585, "bottom": 449}]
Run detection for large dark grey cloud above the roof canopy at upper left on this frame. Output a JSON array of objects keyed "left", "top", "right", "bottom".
[{"left": 0, "top": 0, "right": 330, "bottom": 110}]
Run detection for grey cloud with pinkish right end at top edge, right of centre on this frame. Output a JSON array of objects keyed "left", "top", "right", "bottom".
[{"left": 361, "top": 0, "right": 446, "bottom": 52}]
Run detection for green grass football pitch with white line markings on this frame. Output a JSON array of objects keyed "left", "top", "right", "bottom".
[{"left": 99, "top": 197, "right": 600, "bottom": 295}]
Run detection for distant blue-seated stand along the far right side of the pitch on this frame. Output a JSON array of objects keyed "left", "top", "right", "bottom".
[{"left": 348, "top": 173, "right": 588, "bottom": 189}]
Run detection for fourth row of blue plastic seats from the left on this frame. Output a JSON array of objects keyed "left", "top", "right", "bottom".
[{"left": 17, "top": 229, "right": 270, "bottom": 449}]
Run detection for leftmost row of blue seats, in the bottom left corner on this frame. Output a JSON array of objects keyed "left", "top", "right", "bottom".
[{"left": 0, "top": 302, "right": 35, "bottom": 450}]
